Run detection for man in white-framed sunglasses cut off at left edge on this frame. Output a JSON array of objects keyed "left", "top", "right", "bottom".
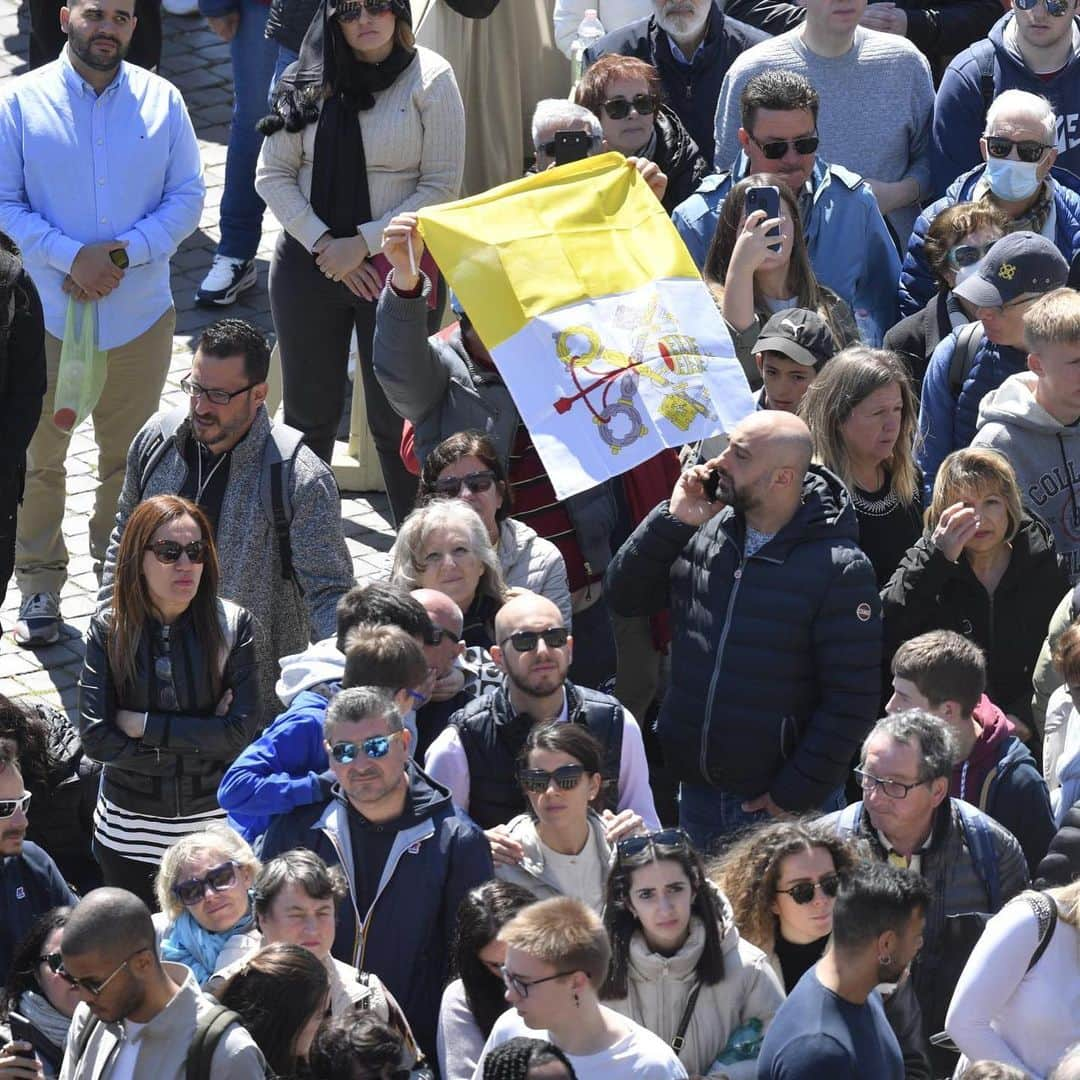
[{"left": 0, "top": 758, "right": 76, "bottom": 982}]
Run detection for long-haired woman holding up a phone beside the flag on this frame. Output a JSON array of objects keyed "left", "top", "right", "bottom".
[{"left": 702, "top": 175, "right": 859, "bottom": 390}]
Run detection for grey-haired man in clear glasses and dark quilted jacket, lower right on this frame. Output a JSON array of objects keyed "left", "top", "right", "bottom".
[{"left": 825, "top": 708, "right": 1028, "bottom": 1076}]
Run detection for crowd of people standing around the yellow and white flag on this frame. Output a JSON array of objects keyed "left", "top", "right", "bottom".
[{"left": 0, "top": 0, "right": 1080, "bottom": 1080}]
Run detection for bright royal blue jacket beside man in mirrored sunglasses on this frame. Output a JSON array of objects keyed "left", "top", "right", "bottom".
[{"left": 217, "top": 690, "right": 329, "bottom": 841}]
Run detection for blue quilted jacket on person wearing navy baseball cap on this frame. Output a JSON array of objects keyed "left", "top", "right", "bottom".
[{"left": 919, "top": 330, "right": 1027, "bottom": 507}]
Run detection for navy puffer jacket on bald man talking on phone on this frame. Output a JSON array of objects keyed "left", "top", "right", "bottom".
[{"left": 605, "top": 465, "right": 881, "bottom": 810}]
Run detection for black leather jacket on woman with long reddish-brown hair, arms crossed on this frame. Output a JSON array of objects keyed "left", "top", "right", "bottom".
[{"left": 79, "top": 600, "right": 259, "bottom": 819}]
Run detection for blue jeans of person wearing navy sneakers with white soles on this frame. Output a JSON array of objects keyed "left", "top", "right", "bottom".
[{"left": 217, "top": 0, "right": 278, "bottom": 259}]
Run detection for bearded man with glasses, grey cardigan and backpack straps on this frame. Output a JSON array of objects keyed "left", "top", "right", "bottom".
[{"left": 98, "top": 319, "right": 353, "bottom": 724}]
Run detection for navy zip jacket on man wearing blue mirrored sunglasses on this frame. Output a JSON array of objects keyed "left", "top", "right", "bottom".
[{"left": 262, "top": 764, "right": 495, "bottom": 1061}]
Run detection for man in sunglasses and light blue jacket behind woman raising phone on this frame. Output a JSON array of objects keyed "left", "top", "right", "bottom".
[{"left": 672, "top": 70, "right": 900, "bottom": 345}]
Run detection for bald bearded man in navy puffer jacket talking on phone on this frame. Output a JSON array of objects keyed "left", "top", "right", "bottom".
[{"left": 605, "top": 411, "right": 881, "bottom": 850}]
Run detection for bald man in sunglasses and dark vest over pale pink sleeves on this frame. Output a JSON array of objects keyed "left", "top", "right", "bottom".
[{"left": 424, "top": 590, "right": 659, "bottom": 862}]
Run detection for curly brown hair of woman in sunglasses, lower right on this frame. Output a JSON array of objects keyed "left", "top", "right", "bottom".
[{"left": 707, "top": 820, "right": 859, "bottom": 953}]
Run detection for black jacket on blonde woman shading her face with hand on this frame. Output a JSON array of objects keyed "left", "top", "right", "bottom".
[{"left": 881, "top": 513, "right": 1069, "bottom": 724}]
